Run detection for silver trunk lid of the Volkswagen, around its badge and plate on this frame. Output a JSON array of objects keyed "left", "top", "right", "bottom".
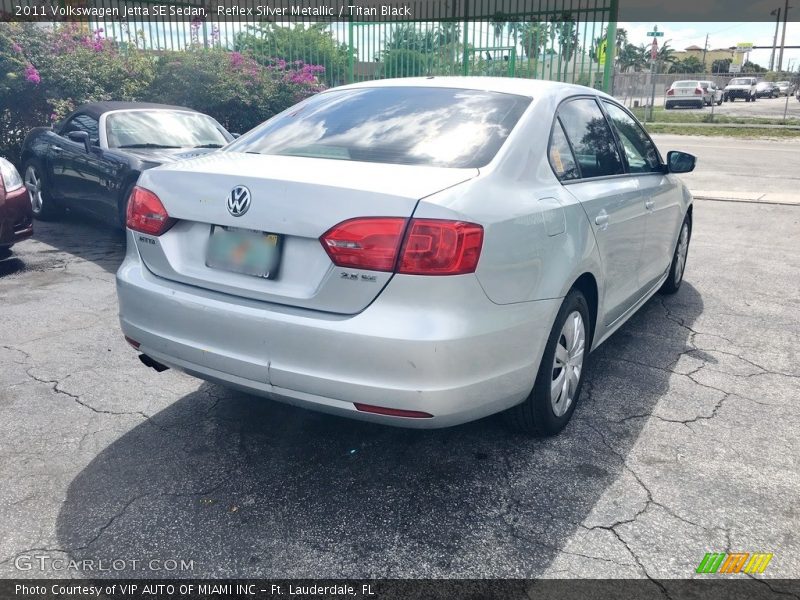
[{"left": 134, "top": 152, "right": 478, "bottom": 314}]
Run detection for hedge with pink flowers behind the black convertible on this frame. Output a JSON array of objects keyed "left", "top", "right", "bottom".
[{"left": 0, "top": 23, "right": 325, "bottom": 161}]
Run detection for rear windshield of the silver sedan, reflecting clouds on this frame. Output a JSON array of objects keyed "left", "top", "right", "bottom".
[{"left": 226, "top": 87, "right": 531, "bottom": 168}]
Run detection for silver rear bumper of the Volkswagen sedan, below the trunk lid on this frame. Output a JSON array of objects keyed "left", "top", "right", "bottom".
[{"left": 117, "top": 233, "right": 561, "bottom": 428}]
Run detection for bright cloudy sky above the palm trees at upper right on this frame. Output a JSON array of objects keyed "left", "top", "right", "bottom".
[{"left": 619, "top": 21, "right": 800, "bottom": 71}]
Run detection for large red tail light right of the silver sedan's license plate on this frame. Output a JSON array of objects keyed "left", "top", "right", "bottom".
[{"left": 320, "top": 217, "right": 483, "bottom": 275}]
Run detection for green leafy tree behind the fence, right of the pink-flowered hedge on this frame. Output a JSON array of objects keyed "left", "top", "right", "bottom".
[{"left": 234, "top": 23, "right": 349, "bottom": 85}]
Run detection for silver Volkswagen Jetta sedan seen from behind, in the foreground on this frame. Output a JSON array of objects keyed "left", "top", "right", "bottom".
[{"left": 117, "top": 78, "right": 695, "bottom": 435}]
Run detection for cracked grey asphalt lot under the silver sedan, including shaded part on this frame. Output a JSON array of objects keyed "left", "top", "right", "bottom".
[{"left": 0, "top": 201, "right": 800, "bottom": 586}]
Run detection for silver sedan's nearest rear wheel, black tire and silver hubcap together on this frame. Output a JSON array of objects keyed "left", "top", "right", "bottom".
[{"left": 505, "top": 290, "right": 592, "bottom": 436}]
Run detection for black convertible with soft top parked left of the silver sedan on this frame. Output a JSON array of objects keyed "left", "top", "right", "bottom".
[{"left": 21, "top": 102, "right": 234, "bottom": 227}]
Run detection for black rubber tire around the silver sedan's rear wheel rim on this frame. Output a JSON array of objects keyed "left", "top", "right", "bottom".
[{"left": 505, "top": 290, "right": 592, "bottom": 436}]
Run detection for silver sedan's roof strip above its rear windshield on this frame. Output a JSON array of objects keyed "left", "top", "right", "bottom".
[{"left": 332, "top": 76, "right": 611, "bottom": 98}]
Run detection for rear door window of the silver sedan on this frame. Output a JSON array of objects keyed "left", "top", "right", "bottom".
[{"left": 558, "top": 98, "right": 625, "bottom": 178}]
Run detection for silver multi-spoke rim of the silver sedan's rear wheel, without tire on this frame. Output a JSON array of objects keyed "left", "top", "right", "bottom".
[{"left": 550, "top": 310, "right": 586, "bottom": 417}]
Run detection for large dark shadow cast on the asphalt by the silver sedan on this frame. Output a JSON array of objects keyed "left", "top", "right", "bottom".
[{"left": 57, "top": 282, "right": 703, "bottom": 578}]
